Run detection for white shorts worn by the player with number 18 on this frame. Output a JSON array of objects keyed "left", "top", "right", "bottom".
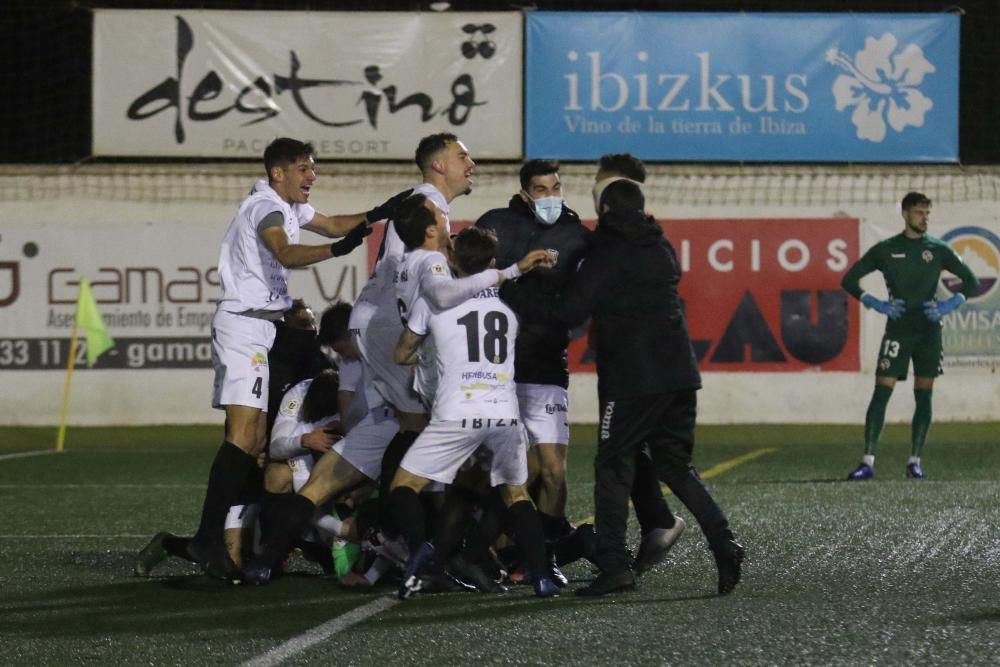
[{"left": 399, "top": 417, "right": 528, "bottom": 486}]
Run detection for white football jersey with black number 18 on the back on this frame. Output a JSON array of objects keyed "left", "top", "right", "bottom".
[{"left": 407, "top": 287, "right": 519, "bottom": 421}]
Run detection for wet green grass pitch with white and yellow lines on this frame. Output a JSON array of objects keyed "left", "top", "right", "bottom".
[{"left": 0, "top": 424, "right": 1000, "bottom": 665}]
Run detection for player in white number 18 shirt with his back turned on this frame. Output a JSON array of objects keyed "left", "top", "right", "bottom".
[{"left": 388, "top": 228, "right": 559, "bottom": 599}]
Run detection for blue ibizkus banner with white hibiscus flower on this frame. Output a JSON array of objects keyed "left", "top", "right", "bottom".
[{"left": 525, "top": 12, "right": 959, "bottom": 162}]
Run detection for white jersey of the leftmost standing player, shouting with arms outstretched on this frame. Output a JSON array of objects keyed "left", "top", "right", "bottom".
[{"left": 218, "top": 179, "right": 316, "bottom": 313}]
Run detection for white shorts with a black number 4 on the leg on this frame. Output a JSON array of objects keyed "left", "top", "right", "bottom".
[{"left": 212, "top": 310, "right": 275, "bottom": 412}]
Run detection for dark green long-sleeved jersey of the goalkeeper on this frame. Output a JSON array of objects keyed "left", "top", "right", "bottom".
[{"left": 840, "top": 233, "right": 979, "bottom": 330}]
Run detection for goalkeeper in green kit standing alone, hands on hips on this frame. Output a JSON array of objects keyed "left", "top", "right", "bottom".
[{"left": 840, "top": 192, "right": 979, "bottom": 480}]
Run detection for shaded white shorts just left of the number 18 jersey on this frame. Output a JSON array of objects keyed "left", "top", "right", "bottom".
[{"left": 350, "top": 301, "right": 427, "bottom": 414}]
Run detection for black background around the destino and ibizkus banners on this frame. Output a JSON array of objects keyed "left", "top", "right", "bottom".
[{"left": 0, "top": 0, "right": 1000, "bottom": 164}]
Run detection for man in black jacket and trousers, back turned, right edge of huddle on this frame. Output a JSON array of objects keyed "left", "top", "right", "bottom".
[{"left": 501, "top": 179, "right": 744, "bottom": 595}]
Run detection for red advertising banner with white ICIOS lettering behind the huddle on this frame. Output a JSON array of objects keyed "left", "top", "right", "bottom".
[{"left": 368, "top": 218, "right": 861, "bottom": 372}]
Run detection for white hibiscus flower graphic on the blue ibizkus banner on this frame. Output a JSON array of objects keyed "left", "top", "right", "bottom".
[{"left": 826, "top": 33, "right": 935, "bottom": 142}]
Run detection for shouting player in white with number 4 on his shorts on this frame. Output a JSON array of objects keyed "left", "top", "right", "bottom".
[{"left": 189, "top": 137, "right": 402, "bottom": 581}]
